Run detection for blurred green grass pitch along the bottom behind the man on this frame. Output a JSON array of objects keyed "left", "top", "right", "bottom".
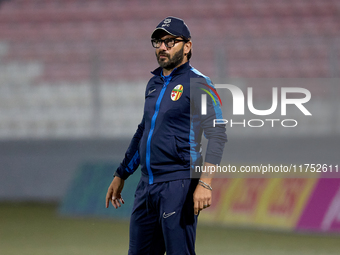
[{"left": 0, "top": 203, "right": 340, "bottom": 255}]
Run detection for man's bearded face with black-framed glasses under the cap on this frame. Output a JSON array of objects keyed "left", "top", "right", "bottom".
[{"left": 156, "top": 35, "right": 184, "bottom": 70}]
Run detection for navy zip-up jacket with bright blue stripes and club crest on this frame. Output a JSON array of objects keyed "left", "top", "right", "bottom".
[{"left": 115, "top": 62, "right": 227, "bottom": 184}]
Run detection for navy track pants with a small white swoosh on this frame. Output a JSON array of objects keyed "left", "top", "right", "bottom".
[{"left": 129, "top": 179, "right": 197, "bottom": 255}]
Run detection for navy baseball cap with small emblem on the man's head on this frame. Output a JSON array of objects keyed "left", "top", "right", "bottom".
[{"left": 151, "top": 17, "right": 191, "bottom": 39}]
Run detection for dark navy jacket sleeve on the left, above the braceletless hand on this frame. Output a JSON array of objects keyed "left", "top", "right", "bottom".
[{"left": 114, "top": 117, "right": 144, "bottom": 180}]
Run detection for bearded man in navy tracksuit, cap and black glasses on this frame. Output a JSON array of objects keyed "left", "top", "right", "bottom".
[{"left": 106, "top": 17, "right": 226, "bottom": 255}]
